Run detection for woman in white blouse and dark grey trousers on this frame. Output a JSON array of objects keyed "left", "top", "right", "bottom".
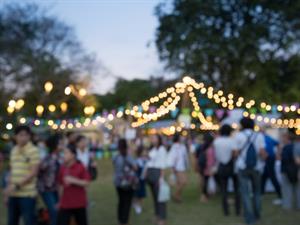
[{"left": 146, "top": 135, "right": 167, "bottom": 225}]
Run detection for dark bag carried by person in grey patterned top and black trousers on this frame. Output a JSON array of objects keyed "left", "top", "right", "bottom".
[{"left": 119, "top": 157, "right": 139, "bottom": 190}]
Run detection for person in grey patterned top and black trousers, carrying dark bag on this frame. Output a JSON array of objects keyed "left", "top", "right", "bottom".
[{"left": 113, "top": 139, "right": 139, "bottom": 225}]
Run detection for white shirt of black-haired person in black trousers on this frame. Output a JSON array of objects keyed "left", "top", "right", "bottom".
[{"left": 213, "top": 136, "right": 238, "bottom": 164}]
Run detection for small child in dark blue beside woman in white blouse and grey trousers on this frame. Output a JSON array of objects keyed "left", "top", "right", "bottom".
[{"left": 133, "top": 146, "right": 147, "bottom": 214}]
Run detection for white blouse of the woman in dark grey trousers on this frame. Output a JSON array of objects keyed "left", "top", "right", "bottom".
[{"left": 147, "top": 146, "right": 168, "bottom": 169}]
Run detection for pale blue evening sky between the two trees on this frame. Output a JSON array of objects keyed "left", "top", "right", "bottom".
[{"left": 0, "top": 0, "right": 169, "bottom": 93}]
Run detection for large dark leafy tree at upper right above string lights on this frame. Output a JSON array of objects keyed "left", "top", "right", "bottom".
[{"left": 156, "top": 0, "right": 300, "bottom": 102}]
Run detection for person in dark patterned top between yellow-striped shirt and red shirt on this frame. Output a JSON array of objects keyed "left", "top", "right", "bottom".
[{"left": 37, "top": 134, "right": 63, "bottom": 225}]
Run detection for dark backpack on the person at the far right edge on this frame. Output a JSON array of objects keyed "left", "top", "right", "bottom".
[{"left": 282, "top": 144, "right": 299, "bottom": 184}]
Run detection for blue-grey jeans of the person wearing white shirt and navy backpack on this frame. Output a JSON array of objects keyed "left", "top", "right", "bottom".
[{"left": 238, "top": 170, "right": 261, "bottom": 224}]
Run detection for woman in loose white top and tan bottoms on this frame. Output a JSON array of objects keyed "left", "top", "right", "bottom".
[{"left": 168, "top": 134, "right": 188, "bottom": 202}]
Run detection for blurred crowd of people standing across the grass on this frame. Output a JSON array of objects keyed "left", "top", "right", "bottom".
[{"left": 0, "top": 118, "right": 300, "bottom": 225}]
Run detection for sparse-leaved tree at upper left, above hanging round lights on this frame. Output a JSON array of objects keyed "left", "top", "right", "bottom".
[{"left": 0, "top": 4, "right": 96, "bottom": 116}]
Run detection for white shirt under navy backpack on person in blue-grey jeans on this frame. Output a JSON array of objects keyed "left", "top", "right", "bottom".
[{"left": 235, "top": 129, "right": 265, "bottom": 172}]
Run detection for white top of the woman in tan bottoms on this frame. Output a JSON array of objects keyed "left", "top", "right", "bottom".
[{"left": 168, "top": 143, "right": 188, "bottom": 172}]
